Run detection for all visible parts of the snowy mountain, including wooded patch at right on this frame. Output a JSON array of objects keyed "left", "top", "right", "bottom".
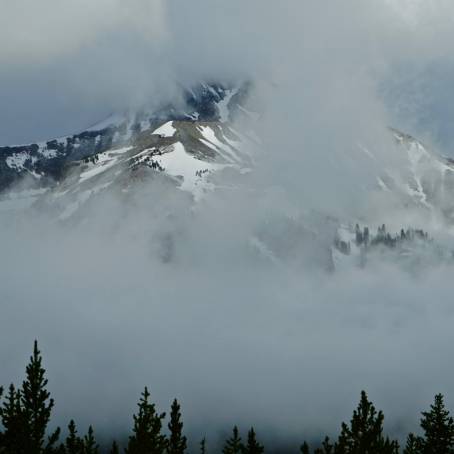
[{"left": 0, "top": 83, "right": 454, "bottom": 269}]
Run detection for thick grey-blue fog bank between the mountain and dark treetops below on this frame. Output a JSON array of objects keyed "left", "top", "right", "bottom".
[{"left": 0, "top": 177, "right": 454, "bottom": 443}]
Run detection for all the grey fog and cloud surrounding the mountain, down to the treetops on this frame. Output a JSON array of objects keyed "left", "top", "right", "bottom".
[{"left": 0, "top": 0, "right": 454, "bottom": 448}]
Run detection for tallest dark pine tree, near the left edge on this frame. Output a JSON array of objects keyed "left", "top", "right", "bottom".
[{"left": 21, "top": 341, "right": 60, "bottom": 454}]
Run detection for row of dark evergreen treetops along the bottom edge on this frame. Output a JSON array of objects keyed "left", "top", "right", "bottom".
[{"left": 0, "top": 341, "right": 454, "bottom": 454}]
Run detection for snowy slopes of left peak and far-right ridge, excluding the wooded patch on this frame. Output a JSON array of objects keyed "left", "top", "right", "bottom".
[{"left": 0, "top": 83, "right": 454, "bottom": 222}]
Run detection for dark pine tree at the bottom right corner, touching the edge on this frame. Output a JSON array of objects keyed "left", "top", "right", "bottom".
[{"left": 421, "top": 394, "right": 454, "bottom": 454}]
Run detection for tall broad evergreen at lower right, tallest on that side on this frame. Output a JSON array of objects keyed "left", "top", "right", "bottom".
[{"left": 334, "top": 391, "right": 399, "bottom": 454}]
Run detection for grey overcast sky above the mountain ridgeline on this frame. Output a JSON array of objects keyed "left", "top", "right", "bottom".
[{"left": 0, "top": 0, "right": 454, "bottom": 151}]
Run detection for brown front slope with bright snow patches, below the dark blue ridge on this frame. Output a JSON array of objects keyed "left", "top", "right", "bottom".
[{"left": 52, "top": 121, "right": 252, "bottom": 219}]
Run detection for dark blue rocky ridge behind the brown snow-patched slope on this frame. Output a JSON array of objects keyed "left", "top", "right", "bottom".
[{"left": 0, "top": 84, "right": 248, "bottom": 191}]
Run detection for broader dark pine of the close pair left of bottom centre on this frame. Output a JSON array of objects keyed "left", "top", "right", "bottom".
[{"left": 125, "top": 388, "right": 167, "bottom": 454}]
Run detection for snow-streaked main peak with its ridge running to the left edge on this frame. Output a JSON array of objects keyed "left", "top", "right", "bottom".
[{"left": 0, "top": 84, "right": 254, "bottom": 220}]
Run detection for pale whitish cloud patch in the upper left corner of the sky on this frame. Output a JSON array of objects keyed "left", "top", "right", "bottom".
[{"left": 0, "top": 0, "right": 165, "bottom": 66}]
